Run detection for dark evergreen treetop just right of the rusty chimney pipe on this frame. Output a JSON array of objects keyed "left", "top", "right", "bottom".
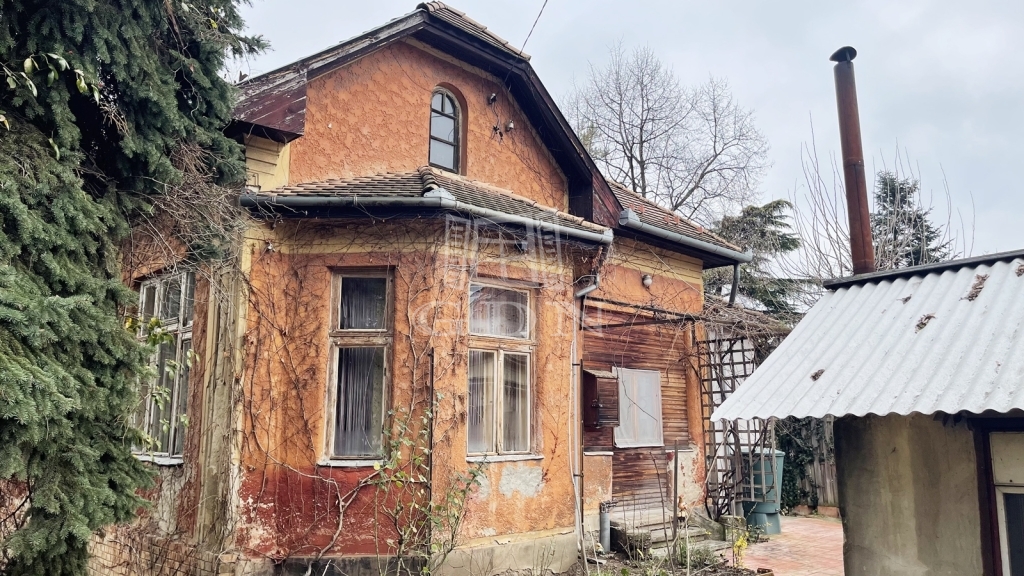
[{"left": 871, "top": 171, "right": 952, "bottom": 270}]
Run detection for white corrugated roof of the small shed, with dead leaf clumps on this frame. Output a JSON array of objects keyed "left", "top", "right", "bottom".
[{"left": 712, "top": 251, "right": 1024, "bottom": 420}]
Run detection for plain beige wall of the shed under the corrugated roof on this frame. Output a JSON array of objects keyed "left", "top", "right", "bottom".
[{"left": 836, "top": 414, "right": 983, "bottom": 576}]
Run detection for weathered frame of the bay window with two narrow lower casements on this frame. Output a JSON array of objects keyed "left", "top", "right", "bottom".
[{"left": 466, "top": 279, "right": 535, "bottom": 460}]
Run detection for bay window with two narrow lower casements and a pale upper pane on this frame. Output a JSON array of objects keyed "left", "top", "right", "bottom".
[{"left": 467, "top": 284, "right": 532, "bottom": 455}]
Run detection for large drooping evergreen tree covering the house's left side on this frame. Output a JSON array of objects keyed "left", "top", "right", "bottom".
[{"left": 0, "top": 0, "right": 261, "bottom": 575}]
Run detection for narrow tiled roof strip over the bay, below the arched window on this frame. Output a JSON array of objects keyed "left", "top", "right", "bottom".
[{"left": 259, "top": 166, "right": 607, "bottom": 233}]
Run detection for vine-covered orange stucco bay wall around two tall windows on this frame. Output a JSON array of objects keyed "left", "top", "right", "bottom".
[{"left": 238, "top": 221, "right": 574, "bottom": 558}]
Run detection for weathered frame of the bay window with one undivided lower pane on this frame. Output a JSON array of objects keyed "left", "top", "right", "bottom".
[{"left": 322, "top": 269, "right": 394, "bottom": 459}]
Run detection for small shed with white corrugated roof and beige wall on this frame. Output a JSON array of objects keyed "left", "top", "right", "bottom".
[{"left": 712, "top": 250, "right": 1024, "bottom": 576}]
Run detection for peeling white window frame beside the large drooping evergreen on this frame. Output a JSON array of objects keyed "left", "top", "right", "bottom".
[{"left": 135, "top": 272, "right": 196, "bottom": 464}]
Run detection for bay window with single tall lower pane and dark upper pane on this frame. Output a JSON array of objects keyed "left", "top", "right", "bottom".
[{"left": 329, "top": 273, "right": 391, "bottom": 458}]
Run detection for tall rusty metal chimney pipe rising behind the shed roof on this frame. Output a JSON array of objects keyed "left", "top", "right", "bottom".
[{"left": 828, "top": 46, "right": 874, "bottom": 275}]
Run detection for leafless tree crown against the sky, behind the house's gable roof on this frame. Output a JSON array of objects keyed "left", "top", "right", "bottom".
[{"left": 565, "top": 44, "right": 769, "bottom": 225}]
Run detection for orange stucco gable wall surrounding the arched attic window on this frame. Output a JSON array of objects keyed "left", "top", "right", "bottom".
[{"left": 288, "top": 42, "right": 568, "bottom": 210}]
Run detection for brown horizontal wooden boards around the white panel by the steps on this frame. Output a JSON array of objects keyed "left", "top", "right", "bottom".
[{"left": 583, "top": 303, "right": 691, "bottom": 507}]
